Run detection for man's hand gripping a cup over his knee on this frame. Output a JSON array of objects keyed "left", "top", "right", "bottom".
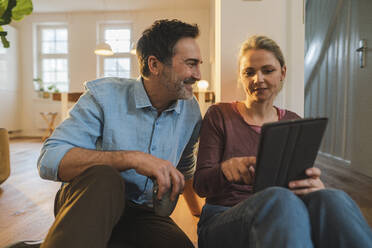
[{"left": 133, "top": 152, "right": 185, "bottom": 201}]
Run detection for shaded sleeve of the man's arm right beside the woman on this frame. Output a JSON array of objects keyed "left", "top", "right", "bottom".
[{"left": 177, "top": 120, "right": 201, "bottom": 180}]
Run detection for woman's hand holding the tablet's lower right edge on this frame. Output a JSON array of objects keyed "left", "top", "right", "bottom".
[{"left": 289, "top": 167, "right": 325, "bottom": 195}]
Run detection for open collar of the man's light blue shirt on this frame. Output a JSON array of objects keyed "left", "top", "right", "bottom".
[{"left": 134, "top": 77, "right": 182, "bottom": 114}]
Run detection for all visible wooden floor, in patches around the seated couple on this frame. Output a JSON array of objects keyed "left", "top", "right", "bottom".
[{"left": 0, "top": 140, "right": 372, "bottom": 247}]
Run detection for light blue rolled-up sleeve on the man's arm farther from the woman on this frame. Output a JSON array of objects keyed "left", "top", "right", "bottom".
[{"left": 37, "top": 90, "right": 103, "bottom": 181}]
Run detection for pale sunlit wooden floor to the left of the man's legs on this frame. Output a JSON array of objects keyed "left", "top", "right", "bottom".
[{"left": 0, "top": 140, "right": 59, "bottom": 247}]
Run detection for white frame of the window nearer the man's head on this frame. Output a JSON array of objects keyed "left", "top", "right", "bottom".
[{"left": 97, "top": 22, "right": 133, "bottom": 77}]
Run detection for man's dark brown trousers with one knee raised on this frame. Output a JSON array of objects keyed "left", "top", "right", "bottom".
[{"left": 41, "top": 166, "right": 194, "bottom": 248}]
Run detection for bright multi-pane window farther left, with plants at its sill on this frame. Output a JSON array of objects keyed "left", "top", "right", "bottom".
[{"left": 36, "top": 25, "right": 69, "bottom": 92}]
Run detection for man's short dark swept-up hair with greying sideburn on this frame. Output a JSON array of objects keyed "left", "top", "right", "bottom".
[{"left": 136, "top": 19, "right": 199, "bottom": 77}]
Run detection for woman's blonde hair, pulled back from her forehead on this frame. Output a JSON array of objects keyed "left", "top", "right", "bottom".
[{"left": 238, "top": 35, "right": 285, "bottom": 67}]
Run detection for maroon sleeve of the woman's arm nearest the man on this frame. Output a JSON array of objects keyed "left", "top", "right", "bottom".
[{"left": 194, "top": 106, "right": 230, "bottom": 197}]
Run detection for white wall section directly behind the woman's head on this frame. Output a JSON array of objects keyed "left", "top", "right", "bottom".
[{"left": 215, "top": 0, "right": 304, "bottom": 115}]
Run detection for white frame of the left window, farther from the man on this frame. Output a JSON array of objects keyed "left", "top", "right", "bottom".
[{"left": 34, "top": 23, "right": 70, "bottom": 92}]
